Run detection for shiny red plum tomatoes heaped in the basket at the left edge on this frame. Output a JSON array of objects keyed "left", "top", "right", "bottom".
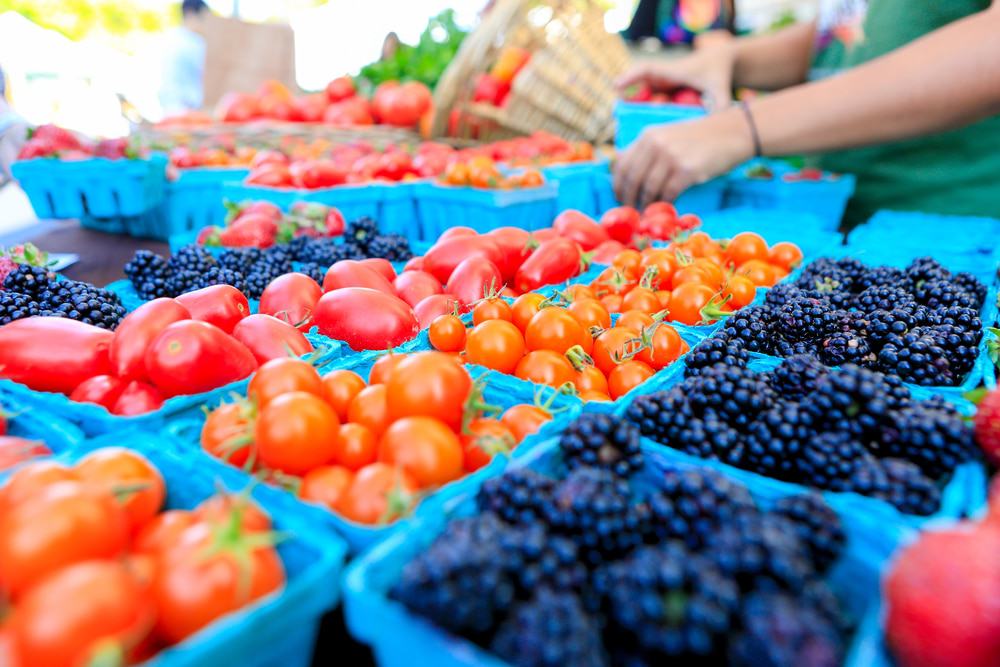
[{"left": 0, "top": 285, "right": 313, "bottom": 416}]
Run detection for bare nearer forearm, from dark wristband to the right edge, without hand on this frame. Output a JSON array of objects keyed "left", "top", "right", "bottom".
[{"left": 752, "top": 6, "right": 1000, "bottom": 155}]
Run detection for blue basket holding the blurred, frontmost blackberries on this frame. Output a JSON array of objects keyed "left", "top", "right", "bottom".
[{"left": 344, "top": 440, "right": 906, "bottom": 667}]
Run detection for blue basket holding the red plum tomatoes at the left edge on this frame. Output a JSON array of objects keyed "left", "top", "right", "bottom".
[{"left": 0, "top": 333, "right": 346, "bottom": 436}]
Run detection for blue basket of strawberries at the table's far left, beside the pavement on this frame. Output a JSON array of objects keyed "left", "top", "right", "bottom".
[{"left": 12, "top": 155, "right": 167, "bottom": 220}]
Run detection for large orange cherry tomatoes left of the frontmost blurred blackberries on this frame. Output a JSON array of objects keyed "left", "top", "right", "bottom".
[{"left": 201, "top": 352, "right": 551, "bottom": 525}]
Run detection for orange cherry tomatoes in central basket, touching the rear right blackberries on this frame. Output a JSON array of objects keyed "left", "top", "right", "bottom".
[{"left": 428, "top": 285, "right": 688, "bottom": 401}]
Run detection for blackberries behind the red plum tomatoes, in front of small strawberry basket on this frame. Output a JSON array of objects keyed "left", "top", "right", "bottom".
[{"left": 125, "top": 218, "right": 413, "bottom": 300}]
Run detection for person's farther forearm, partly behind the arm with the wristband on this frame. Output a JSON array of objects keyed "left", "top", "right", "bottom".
[{"left": 728, "top": 23, "right": 816, "bottom": 90}]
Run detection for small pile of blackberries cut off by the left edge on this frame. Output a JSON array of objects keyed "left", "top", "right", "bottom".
[{"left": 0, "top": 265, "right": 126, "bottom": 331}]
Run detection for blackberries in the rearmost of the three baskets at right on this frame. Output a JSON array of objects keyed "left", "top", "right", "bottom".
[{"left": 716, "top": 257, "right": 986, "bottom": 386}]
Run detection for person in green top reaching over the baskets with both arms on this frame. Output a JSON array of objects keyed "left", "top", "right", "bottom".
[{"left": 614, "top": 0, "right": 1000, "bottom": 228}]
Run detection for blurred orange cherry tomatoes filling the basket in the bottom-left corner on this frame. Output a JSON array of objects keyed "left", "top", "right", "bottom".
[{"left": 0, "top": 447, "right": 285, "bottom": 667}]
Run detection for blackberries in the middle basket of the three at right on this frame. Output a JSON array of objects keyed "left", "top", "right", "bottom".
[{"left": 625, "top": 355, "right": 978, "bottom": 515}]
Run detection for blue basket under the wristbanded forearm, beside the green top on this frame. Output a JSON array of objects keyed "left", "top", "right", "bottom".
[{"left": 726, "top": 160, "right": 856, "bottom": 232}]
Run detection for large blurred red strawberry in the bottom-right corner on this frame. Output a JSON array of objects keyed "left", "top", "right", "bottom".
[{"left": 885, "top": 522, "right": 1000, "bottom": 667}]
